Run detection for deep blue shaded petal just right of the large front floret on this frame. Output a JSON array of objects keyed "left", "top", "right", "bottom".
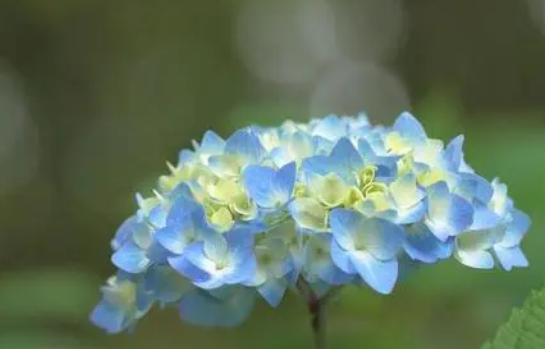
[{"left": 403, "top": 224, "right": 453, "bottom": 263}]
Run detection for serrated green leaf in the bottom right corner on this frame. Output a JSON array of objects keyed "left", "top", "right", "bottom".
[{"left": 481, "top": 289, "right": 545, "bottom": 349}]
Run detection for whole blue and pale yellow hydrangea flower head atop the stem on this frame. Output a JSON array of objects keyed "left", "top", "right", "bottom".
[{"left": 91, "top": 113, "right": 530, "bottom": 333}]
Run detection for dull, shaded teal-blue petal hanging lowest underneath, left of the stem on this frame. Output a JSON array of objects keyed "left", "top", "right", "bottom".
[{"left": 180, "top": 288, "right": 255, "bottom": 327}]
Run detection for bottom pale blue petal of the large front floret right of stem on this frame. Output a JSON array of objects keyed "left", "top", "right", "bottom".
[{"left": 352, "top": 252, "right": 398, "bottom": 294}]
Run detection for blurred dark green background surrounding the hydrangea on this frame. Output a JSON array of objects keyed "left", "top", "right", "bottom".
[{"left": 0, "top": 0, "right": 545, "bottom": 349}]
